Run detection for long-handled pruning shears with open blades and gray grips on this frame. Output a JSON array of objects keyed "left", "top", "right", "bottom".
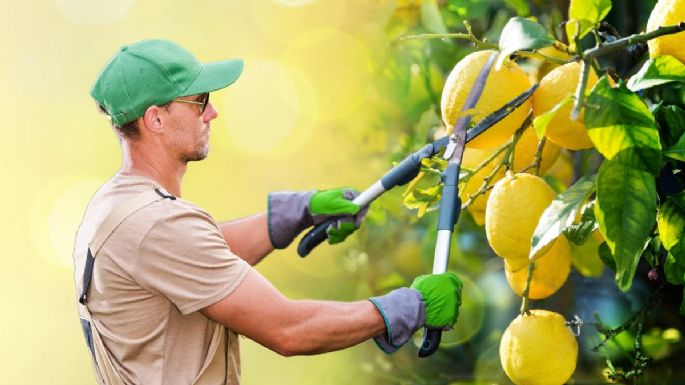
[{"left": 297, "top": 53, "right": 538, "bottom": 358}]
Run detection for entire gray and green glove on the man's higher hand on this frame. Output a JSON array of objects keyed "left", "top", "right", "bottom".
[{"left": 268, "top": 188, "right": 367, "bottom": 249}]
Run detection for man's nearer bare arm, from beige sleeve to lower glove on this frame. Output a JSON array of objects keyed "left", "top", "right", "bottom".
[{"left": 202, "top": 270, "right": 386, "bottom": 356}]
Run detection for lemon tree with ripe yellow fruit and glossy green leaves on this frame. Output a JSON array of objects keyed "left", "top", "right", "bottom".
[{"left": 362, "top": 0, "right": 685, "bottom": 385}]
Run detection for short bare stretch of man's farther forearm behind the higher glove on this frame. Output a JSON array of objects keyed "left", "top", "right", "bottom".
[{"left": 219, "top": 213, "right": 273, "bottom": 266}]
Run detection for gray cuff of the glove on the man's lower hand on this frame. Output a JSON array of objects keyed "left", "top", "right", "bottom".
[{"left": 369, "top": 287, "right": 426, "bottom": 354}]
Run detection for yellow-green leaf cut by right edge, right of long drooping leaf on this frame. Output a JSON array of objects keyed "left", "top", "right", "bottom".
[{"left": 657, "top": 192, "right": 685, "bottom": 284}]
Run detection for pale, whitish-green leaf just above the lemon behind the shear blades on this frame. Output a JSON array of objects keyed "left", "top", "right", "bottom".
[{"left": 497, "top": 16, "right": 554, "bottom": 68}]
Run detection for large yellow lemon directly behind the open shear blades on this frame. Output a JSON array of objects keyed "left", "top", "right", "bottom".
[{"left": 440, "top": 50, "right": 530, "bottom": 148}]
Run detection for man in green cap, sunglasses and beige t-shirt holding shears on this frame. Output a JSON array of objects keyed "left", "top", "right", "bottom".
[{"left": 74, "top": 40, "right": 461, "bottom": 385}]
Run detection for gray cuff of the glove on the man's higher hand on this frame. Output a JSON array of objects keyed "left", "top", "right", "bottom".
[{"left": 268, "top": 190, "right": 315, "bottom": 249}]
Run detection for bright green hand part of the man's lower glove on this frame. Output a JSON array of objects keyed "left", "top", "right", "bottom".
[{"left": 411, "top": 272, "right": 463, "bottom": 330}]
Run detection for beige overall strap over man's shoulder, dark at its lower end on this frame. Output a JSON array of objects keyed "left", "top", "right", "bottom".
[{"left": 78, "top": 188, "right": 176, "bottom": 305}]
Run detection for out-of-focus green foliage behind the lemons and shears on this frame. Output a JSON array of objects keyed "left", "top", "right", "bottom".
[{"left": 357, "top": 0, "right": 685, "bottom": 384}]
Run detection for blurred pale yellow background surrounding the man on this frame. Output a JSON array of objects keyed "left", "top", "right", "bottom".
[{"left": 0, "top": 0, "right": 394, "bottom": 385}]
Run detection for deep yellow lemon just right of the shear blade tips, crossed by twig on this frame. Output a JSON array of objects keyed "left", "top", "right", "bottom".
[{"left": 533, "top": 62, "right": 597, "bottom": 150}]
